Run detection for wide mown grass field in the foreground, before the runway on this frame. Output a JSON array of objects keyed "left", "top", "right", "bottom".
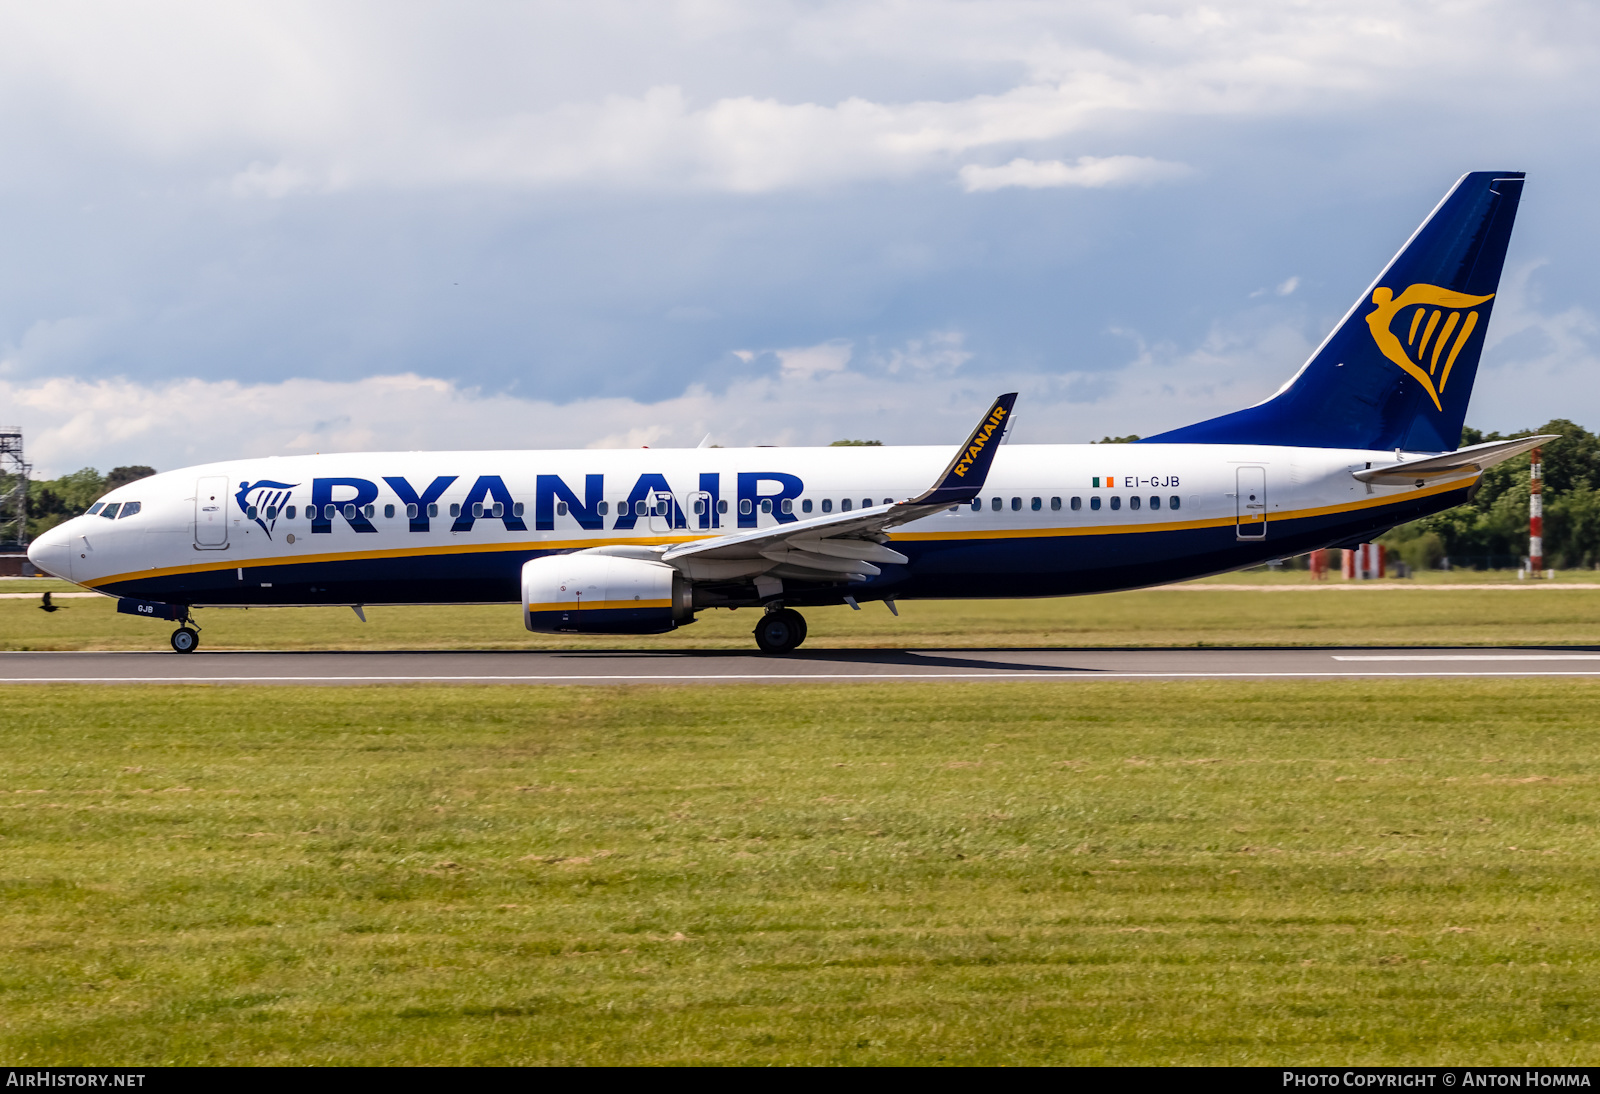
[{"left": 0, "top": 678, "right": 1600, "bottom": 1065}]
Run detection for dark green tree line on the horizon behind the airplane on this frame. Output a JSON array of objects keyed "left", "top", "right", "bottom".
[{"left": 0, "top": 417, "right": 1600, "bottom": 569}]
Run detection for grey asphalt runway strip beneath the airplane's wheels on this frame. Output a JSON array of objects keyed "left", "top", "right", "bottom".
[{"left": 0, "top": 646, "right": 1600, "bottom": 686}]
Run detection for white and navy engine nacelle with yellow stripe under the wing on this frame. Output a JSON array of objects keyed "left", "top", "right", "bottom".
[{"left": 522, "top": 552, "right": 694, "bottom": 635}]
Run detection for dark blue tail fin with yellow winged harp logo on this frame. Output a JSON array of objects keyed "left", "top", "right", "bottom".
[{"left": 1144, "top": 171, "right": 1523, "bottom": 453}]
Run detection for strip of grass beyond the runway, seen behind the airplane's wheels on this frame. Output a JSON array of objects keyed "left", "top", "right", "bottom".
[{"left": 9, "top": 573, "right": 1600, "bottom": 651}]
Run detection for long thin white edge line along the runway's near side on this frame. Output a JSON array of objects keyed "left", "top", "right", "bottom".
[{"left": 9, "top": 669, "right": 1600, "bottom": 685}]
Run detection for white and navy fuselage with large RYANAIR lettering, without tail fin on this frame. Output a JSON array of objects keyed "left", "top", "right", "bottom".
[{"left": 30, "top": 445, "right": 1477, "bottom": 606}]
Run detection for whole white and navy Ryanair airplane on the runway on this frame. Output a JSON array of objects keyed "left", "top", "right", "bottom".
[{"left": 29, "top": 171, "right": 1552, "bottom": 654}]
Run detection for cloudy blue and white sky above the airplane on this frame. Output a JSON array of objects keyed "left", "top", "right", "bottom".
[{"left": 0, "top": 0, "right": 1600, "bottom": 475}]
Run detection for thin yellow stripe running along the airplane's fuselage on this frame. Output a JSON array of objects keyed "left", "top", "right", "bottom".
[{"left": 87, "top": 475, "right": 1477, "bottom": 589}]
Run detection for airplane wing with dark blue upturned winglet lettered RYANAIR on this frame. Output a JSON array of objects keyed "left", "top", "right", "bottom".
[{"left": 636, "top": 392, "right": 1016, "bottom": 582}]
